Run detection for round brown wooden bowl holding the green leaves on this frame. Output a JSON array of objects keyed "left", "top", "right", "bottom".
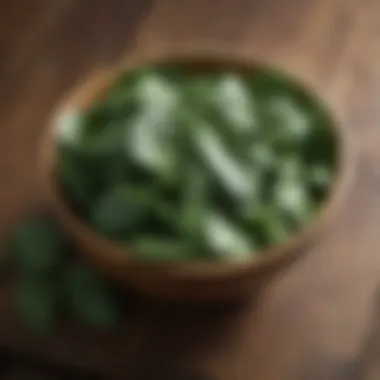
[{"left": 41, "top": 49, "right": 352, "bottom": 301}]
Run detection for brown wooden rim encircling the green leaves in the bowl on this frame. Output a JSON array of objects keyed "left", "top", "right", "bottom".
[{"left": 40, "top": 47, "right": 354, "bottom": 278}]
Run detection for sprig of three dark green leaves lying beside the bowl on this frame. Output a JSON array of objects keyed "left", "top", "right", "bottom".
[{"left": 11, "top": 217, "right": 122, "bottom": 334}]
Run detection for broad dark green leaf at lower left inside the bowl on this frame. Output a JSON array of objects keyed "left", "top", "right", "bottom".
[{"left": 91, "top": 183, "right": 154, "bottom": 240}]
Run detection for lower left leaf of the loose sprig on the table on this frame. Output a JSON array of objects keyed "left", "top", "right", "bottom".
[{"left": 15, "top": 277, "right": 59, "bottom": 334}]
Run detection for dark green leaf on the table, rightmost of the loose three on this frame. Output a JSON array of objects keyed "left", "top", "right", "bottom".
[{"left": 63, "top": 264, "right": 121, "bottom": 329}]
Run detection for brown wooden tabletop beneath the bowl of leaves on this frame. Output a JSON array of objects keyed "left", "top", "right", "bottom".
[{"left": 0, "top": 0, "right": 380, "bottom": 380}]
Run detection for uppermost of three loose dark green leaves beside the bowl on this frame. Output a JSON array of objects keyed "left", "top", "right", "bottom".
[{"left": 11, "top": 218, "right": 67, "bottom": 275}]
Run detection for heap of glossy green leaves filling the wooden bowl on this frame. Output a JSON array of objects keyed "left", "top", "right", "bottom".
[{"left": 57, "top": 68, "right": 334, "bottom": 260}]
